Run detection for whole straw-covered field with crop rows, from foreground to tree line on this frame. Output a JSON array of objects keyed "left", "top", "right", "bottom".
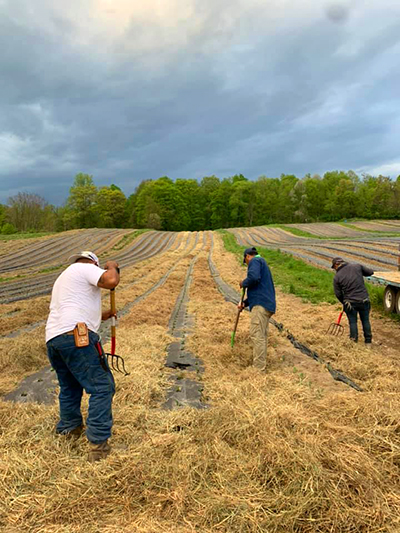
[{"left": 0, "top": 221, "right": 400, "bottom": 533}]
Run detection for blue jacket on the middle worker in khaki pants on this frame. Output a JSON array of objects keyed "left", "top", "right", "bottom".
[{"left": 242, "top": 255, "right": 276, "bottom": 313}]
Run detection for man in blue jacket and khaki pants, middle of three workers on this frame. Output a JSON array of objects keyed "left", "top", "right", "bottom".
[{"left": 238, "top": 247, "right": 276, "bottom": 372}]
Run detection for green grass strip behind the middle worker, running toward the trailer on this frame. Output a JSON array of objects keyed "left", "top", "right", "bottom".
[{"left": 219, "top": 230, "right": 388, "bottom": 312}]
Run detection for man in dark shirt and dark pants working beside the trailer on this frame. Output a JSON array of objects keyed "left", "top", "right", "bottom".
[{"left": 332, "top": 257, "right": 374, "bottom": 345}]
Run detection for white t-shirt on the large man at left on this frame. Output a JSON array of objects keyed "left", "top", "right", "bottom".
[{"left": 46, "top": 263, "right": 106, "bottom": 342}]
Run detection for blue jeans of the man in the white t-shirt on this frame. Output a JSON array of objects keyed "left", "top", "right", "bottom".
[{"left": 47, "top": 331, "right": 115, "bottom": 444}]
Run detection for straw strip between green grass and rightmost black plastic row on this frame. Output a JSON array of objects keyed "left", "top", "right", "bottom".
[{"left": 214, "top": 235, "right": 400, "bottom": 393}]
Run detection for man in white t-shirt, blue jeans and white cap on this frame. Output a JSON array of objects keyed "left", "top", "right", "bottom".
[{"left": 46, "top": 251, "right": 119, "bottom": 461}]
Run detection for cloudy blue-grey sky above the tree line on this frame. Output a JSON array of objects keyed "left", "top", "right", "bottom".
[{"left": 0, "top": 0, "right": 400, "bottom": 204}]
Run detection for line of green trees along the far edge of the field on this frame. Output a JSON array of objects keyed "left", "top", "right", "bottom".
[{"left": 0, "top": 170, "right": 400, "bottom": 233}]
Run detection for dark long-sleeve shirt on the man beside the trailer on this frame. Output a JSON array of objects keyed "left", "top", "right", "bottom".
[{"left": 333, "top": 263, "right": 374, "bottom": 303}]
